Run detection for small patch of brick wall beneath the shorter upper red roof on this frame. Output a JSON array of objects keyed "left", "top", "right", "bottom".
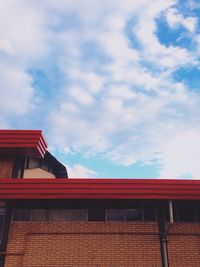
[{"left": 0, "top": 157, "right": 14, "bottom": 178}]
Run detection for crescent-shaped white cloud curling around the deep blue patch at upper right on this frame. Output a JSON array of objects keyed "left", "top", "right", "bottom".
[{"left": 133, "top": 5, "right": 195, "bottom": 72}]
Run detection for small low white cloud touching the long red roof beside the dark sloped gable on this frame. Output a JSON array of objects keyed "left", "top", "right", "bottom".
[{"left": 67, "top": 164, "right": 97, "bottom": 178}]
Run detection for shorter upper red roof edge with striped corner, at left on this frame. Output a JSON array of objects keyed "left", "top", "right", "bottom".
[{"left": 0, "top": 130, "right": 47, "bottom": 157}]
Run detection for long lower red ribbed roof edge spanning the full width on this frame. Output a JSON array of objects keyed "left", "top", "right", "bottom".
[{"left": 0, "top": 179, "right": 200, "bottom": 200}]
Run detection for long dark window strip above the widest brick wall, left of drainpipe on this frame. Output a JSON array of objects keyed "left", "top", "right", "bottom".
[{"left": 13, "top": 200, "right": 156, "bottom": 221}]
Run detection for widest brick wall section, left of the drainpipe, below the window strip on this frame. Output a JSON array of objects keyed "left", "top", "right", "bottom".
[{"left": 5, "top": 222, "right": 161, "bottom": 267}]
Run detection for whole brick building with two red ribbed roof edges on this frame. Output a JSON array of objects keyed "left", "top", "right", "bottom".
[{"left": 0, "top": 131, "right": 200, "bottom": 267}]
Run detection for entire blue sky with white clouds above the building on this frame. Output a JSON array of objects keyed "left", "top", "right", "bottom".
[{"left": 0, "top": 0, "right": 200, "bottom": 179}]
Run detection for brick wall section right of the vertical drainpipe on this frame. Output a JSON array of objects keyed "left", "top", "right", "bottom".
[{"left": 168, "top": 223, "right": 200, "bottom": 267}]
